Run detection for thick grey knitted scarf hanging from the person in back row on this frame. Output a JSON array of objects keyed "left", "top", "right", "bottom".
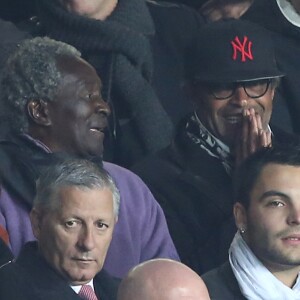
[{"left": 37, "top": 0, "right": 172, "bottom": 152}]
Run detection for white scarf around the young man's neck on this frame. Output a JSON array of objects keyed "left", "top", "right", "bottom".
[{"left": 229, "top": 232, "right": 300, "bottom": 300}]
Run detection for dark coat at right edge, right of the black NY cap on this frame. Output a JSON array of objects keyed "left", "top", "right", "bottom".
[{"left": 242, "top": 0, "right": 300, "bottom": 134}]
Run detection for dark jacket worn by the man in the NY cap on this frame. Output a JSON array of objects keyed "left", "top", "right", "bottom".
[{"left": 132, "top": 116, "right": 296, "bottom": 274}]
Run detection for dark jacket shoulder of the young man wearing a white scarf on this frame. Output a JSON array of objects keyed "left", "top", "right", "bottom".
[{"left": 202, "top": 261, "right": 246, "bottom": 300}]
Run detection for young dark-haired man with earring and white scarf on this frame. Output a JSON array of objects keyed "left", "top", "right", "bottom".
[{"left": 203, "top": 143, "right": 300, "bottom": 300}]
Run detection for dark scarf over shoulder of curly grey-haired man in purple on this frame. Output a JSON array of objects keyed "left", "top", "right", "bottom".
[{"left": 0, "top": 135, "right": 102, "bottom": 209}]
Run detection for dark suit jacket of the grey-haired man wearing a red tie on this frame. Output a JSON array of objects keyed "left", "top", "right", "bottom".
[{"left": 0, "top": 242, "right": 119, "bottom": 300}]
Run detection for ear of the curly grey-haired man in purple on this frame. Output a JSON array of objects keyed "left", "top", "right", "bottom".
[{"left": 27, "top": 99, "right": 51, "bottom": 126}]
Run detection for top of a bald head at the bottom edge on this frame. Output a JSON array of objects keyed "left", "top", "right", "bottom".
[{"left": 118, "top": 259, "right": 210, "bottom": 300}]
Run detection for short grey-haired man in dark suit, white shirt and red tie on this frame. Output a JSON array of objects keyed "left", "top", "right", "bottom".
[{"left": 0, "top": 159, "right": 120, "bottom": 300}]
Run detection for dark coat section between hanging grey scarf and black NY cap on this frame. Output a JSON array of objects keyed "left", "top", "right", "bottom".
[{"left": 146, "top": 1, "right": 204, "bottom": 125}]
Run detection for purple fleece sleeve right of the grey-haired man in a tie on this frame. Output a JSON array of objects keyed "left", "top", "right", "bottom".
[{"left": 104, "top": 163, "right": 179, "bottom": 277}]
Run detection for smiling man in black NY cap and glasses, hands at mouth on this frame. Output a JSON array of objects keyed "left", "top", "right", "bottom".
[{"left": 134, "top": 20, "right": 294, "bottom": 274}]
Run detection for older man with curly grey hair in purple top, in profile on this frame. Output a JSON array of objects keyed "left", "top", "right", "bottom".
[{"left": 0, "top": 38, "right": 178, "bottom": 277}]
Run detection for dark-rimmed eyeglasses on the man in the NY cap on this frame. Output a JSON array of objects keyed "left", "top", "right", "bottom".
[{"left": 205, "top": 79, "right": 271, "bottom": 100}]
